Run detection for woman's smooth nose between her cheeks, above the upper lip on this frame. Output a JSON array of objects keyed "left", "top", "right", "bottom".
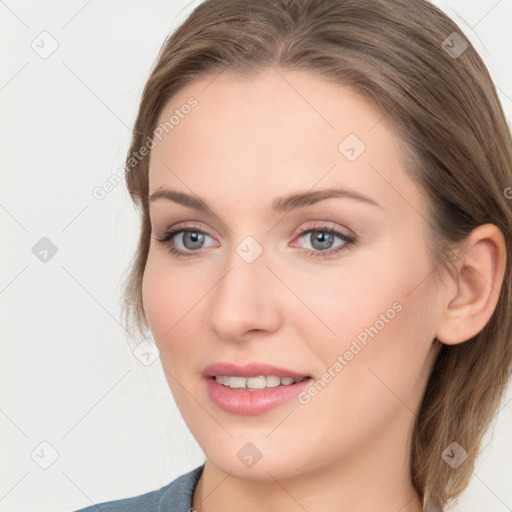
[{"left": 208, "top": 246, "right": 285, "bottom": 341}]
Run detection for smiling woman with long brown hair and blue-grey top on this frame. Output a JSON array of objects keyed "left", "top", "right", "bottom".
[{"left": 74, "top": 0, "right": 512, "bottom": 512}]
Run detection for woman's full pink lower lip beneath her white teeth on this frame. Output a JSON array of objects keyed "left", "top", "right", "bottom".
[{"left": 206, "top": 377, "right": 312, "bottom": 416}]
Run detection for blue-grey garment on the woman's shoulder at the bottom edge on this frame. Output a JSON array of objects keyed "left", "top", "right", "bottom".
[{"left": 72, "top": 465, "right": 204, "bottom": 512}]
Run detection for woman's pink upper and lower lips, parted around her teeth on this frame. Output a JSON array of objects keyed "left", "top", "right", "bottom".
[{"left": 202, "top": 363, "right": 313, "bottom": 416}]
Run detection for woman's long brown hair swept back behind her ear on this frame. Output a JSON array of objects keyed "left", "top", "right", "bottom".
[{"left": 123, "top": 0, "right": 512, "bottom": 511}]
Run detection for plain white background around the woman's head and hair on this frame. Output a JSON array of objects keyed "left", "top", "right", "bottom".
[{"left": 0, "top": 0, "right": 512, "bottom": 512}]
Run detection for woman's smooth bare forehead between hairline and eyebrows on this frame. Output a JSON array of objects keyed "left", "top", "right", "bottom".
[{"left": 150, "top": 68, "right": 421, "bottom": 220}]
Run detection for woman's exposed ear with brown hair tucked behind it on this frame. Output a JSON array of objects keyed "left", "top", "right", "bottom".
[{"left": 436, "top": 224, "right": 507, "bottom": 345}]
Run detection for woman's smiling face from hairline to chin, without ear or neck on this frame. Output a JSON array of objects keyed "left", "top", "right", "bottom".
[{"left": 143, "top": 70, "right": 442, "bottom": 480}]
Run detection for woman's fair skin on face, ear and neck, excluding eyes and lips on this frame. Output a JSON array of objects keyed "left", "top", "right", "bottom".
[{"left": 143, "top": 68, "right": 505, "bottom": 512}]
